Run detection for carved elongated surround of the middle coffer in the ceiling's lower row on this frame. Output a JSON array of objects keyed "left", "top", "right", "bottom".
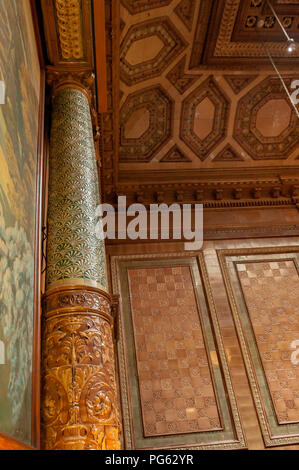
[{"left": 181, "top": 77, "right": 229, "bottom": 160}]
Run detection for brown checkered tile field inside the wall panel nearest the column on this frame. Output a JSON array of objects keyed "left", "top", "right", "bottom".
[{"left": 128, "top": 267, "right": 221, "bottom": 436}]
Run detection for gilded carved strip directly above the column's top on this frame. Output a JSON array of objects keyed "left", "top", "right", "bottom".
[{"left": 55, "top": 0, "right": 84, "bottom": 60}]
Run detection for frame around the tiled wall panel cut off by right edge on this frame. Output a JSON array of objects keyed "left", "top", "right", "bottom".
[{"left": 217, "top": 246, "right": 299, "bottom": 447}]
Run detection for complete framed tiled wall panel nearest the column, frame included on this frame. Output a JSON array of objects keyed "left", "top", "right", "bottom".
[{"left": 112, "top": 253, "right": 246, "bottom": 449}]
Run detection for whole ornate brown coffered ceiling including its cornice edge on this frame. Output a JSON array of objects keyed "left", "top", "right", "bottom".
[{"left": 97, "top": 0, "right": 299, "bottom": 207}]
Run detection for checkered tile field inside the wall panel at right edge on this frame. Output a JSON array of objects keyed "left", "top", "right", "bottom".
[{"left": 237, "top": 260, "right": 299, "bottom": 424}]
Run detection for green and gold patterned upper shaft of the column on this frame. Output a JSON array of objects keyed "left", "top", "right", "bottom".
[{"left": 47, "top": 88, "right": 107, "bottom": 290}]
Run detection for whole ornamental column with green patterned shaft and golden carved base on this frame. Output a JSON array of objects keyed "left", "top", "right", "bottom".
[{"left": 41, "top": 75, "right": 120, "bottom": 450}]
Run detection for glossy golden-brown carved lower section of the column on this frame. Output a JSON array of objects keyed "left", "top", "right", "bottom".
[{"left": 42, "top": 299, "right": 120, "bottom": 450}]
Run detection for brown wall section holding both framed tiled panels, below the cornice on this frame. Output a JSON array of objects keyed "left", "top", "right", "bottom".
[{"left": 108, "top": 237, "right": 299, "bottom": 450}]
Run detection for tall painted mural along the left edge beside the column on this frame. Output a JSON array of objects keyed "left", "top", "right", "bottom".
[{"left": 0, "top": 0, "right": 40, "bottom": 442}]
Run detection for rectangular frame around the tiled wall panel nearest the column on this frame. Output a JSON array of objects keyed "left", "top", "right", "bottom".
[{"left": 111, "top": 252, "right": 246, "bottom": 450}]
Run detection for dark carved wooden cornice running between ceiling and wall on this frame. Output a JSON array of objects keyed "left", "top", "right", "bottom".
[{"left": 105, "top": 169, "right": 299, "bottom": 208}]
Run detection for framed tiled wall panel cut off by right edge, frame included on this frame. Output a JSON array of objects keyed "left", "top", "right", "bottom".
[{"left": 219, "top": 247, "right": 299, "bottom": 447}]
